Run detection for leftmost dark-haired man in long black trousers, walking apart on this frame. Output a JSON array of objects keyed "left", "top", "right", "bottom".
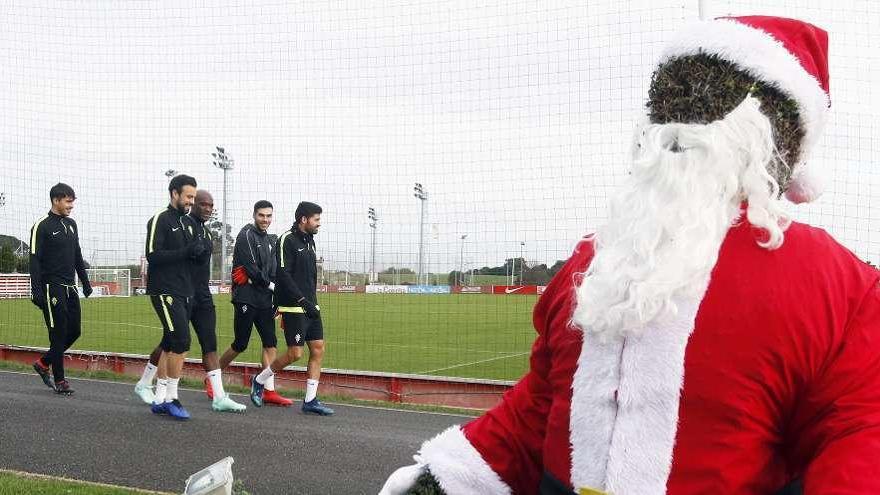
[{"left": 30, "top": 183, "right": 92, "bottom": 395}]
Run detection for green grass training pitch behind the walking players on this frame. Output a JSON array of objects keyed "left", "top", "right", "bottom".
[{"left": 0, "top": 294, "right": 537, "bottom": 380}]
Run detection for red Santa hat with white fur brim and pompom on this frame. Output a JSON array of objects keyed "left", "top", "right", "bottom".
[{"left": 660, "top": 16, "right": 831, "bottom": 203}]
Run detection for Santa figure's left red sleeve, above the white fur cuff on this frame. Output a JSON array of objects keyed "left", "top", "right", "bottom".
[{"left": 463, "top": 241, "right": 593, "bottom": 493}]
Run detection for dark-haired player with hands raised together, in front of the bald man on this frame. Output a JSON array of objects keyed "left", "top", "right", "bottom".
[{"left": 145, "top": 175, "right": 207, "bottom": 420}]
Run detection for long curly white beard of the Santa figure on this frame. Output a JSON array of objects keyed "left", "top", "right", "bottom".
[{"left": 572, "top": 96, "right": 790, "bottom": 341}]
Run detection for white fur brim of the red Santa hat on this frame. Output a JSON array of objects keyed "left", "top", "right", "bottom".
[{"left": 660, "top": 19, "right": 829, "bottom": 176}]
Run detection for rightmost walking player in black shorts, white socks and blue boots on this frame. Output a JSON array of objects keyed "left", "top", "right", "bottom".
[{"left": 251, "top": 201, "right": 333, "bottom": 416}]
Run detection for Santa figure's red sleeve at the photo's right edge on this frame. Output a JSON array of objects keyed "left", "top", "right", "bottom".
[{"left": 793, "top": 283, "right": 880, "bottom": 495}]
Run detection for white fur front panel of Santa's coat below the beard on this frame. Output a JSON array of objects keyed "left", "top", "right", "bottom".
[{"left": 571, "top": 296, "right": 705, "bottom": 495}]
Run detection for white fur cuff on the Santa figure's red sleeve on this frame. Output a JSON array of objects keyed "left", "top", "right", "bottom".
[{"left": 418, "top": 425, "right": 510, "bottom": 495}]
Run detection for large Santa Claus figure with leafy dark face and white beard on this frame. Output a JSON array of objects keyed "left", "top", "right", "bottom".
[{"left": 382, "top": 13, "right": 880, "bottom": 495}]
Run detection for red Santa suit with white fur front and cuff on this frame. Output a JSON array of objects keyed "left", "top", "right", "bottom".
[{"left": 420, "top": 221, "right": 880, "bottom": 495}]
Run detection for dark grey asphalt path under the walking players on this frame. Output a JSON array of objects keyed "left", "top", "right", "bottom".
[{"left": 0, "top": 371, "right": 468, "bottom": 495}]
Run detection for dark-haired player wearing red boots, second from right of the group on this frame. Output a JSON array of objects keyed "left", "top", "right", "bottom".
[{"left": 220, "top": 200, "right": 293, "bottom": 406}]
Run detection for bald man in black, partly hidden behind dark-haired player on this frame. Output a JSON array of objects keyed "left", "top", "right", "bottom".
[{"left": 134, "top": 189, "right": 246, "bottom": 412}]
